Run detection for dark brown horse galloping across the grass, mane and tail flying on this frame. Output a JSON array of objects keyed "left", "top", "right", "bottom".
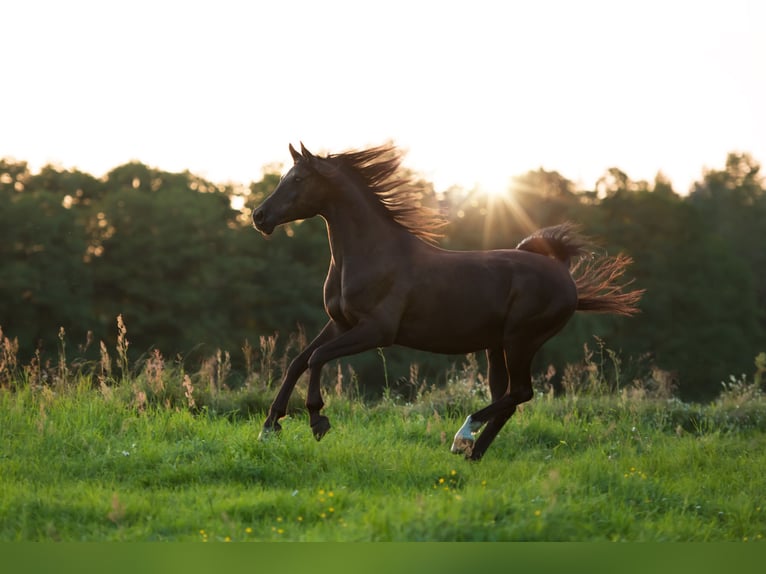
[{"left": 253, "top": 144, "right": 641, "bottom": 459}]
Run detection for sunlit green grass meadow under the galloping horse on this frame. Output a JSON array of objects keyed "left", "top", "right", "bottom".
[{"left": 0, "top": 352, "right": 766, "bottom": 542}]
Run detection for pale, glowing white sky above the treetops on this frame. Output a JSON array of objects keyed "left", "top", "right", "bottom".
[{"left": 0, "top": 0, "right": 766, "bottom": 193}]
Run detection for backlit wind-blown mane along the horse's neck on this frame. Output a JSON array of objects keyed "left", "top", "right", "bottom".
[{"left": 326, "top": 144, "right": 446, "bottom": 243}]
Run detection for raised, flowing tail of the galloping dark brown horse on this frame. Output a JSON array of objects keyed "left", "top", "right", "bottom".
[{"left": 516, "top": 223, "right": 644, "bottom": 316}]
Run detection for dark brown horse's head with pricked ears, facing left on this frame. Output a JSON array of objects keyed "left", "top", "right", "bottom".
[{"left": 253, "top": 143, "right": 331, "bottom": 235}]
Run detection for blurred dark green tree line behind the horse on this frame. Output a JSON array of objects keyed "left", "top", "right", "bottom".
[{"left": 0, "top": 153, "right": 766, "bottom": 399}]
